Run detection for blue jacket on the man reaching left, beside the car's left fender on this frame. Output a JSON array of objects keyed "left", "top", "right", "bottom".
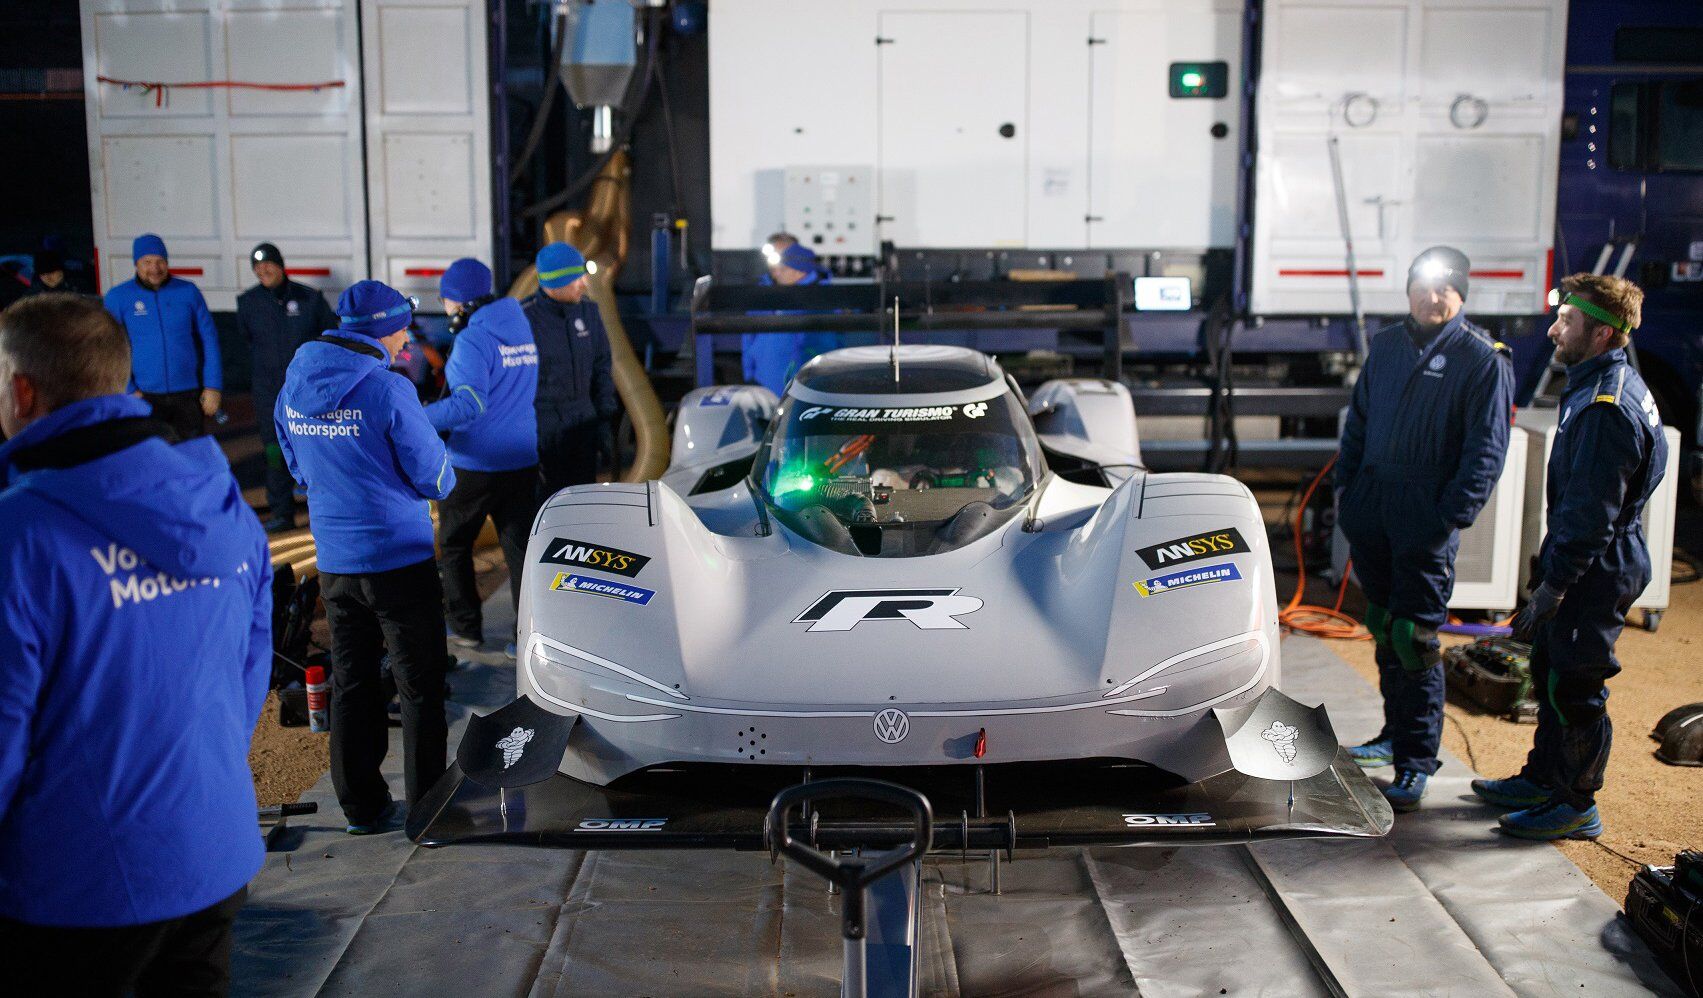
[{"left": 426, "top": 298, "right": 538, "bottom": 472}]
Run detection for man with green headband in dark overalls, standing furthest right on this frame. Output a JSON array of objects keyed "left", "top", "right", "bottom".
[{"left": 1473, "top": 274, "right": 1667, "bottom": 840}]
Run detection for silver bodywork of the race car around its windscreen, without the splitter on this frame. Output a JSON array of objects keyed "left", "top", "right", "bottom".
[{"left": 518, "top": 347, "right": 1279, "bottom": 783}]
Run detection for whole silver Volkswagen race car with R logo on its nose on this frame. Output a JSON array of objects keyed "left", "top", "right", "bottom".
[{"left": 410, "top": 346, "right": 1390, "bottom": 848}]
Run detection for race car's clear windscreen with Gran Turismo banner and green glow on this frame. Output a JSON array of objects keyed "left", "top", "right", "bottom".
[{"left": 754, "top": 392, "right": 1044, "bottom": 526}]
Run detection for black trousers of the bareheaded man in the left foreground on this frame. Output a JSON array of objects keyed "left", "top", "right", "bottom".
[{"left": 0, "top": 887, "right": 249, "bottom": 998}]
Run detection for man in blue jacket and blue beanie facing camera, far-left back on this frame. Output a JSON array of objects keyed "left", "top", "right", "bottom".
[{"left": 106, "top": 232, "right": 225, "bottom": 439}]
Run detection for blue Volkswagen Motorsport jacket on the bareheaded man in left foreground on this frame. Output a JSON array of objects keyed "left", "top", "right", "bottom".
[{"left": 0, "top": 395, "right": 272, "bottom": 926}]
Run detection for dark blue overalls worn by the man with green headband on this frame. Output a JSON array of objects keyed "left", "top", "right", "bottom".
[{"left": 1521, "top": 349, "right": 1667, "bottom": 811}]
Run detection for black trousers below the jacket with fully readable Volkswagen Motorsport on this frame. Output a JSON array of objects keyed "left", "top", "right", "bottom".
[{"left": 320, "top": 560, "right": 450, "bottom": 824}]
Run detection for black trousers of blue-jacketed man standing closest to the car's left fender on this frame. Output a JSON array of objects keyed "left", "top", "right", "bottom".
[{"left": 438, "top": 467, "right": 538, "bottom": 639}]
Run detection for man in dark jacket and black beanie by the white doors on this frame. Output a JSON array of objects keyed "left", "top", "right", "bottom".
[{"left": 237, "top": 242, "right": 337, "bottom": 533}]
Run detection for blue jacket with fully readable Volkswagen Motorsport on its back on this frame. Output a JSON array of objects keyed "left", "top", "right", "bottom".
[{"left": 272, "top": 330, "right": 455, "bottom": 576}]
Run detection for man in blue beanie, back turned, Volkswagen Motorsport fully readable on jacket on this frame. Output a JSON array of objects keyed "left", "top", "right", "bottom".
[{"left": 274, "top": 281, "right": 455, "bottom": 835}]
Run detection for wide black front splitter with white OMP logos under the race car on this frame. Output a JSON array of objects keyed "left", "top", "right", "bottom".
[{"left": 407, "top": 749, "right": 1395, "bottom": 852}]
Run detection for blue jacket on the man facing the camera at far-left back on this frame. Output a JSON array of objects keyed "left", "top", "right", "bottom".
[{"left": 106, "top": 278, "right": 225, "bottom": 395}]
